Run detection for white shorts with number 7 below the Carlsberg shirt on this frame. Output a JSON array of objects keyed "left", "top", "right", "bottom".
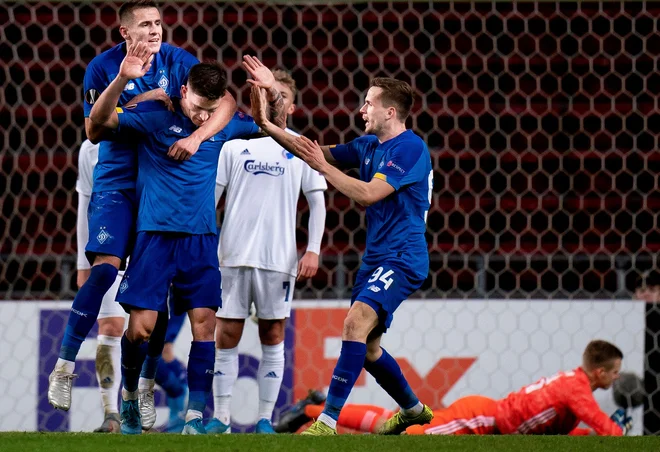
[{"left": 216, "top": 267, "right": 296, "bottom": 320}]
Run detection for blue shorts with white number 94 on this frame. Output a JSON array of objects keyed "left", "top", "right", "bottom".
[{"left": 351, "top": 259, "right": 424, "bottom": 332}]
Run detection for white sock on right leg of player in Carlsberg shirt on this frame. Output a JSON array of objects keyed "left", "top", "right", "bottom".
[{"left": 257, "top": 342, "right": 284, "bottom": 421}]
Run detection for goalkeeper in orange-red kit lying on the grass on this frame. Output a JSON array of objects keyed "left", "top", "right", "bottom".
[{"left": 275, "top": 340, "right": 632, "bottom": 436}]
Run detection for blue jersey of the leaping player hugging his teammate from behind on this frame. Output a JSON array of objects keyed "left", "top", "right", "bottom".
[{"left": 83, "top": 42, "right": 199, "bottom": 192}]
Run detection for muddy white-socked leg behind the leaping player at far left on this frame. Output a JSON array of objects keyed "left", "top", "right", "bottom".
[{"left": 94, "top": 317, "right": 125, "bottom": 433}]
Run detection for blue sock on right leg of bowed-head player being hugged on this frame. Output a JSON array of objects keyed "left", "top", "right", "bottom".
[{"left": 188, "top": 341, "right": 215, "bottom": 413}]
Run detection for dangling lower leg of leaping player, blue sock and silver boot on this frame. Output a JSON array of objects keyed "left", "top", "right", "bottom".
[{"left": 48, "top": 255, "right": 121, "bottom": 411}]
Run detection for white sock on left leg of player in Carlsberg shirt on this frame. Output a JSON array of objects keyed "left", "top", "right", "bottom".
[{"left": 213, "top": 347, "right": 238, "bottom": 425}]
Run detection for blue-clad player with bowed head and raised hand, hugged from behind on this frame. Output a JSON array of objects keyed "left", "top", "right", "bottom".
[{"left": 90, "top": 42, "right": 284, "bottom": 434}]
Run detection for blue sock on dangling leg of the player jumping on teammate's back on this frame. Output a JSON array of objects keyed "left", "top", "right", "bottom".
[{"left": 60, "top": 264, "right": 117, "bottom": 361}]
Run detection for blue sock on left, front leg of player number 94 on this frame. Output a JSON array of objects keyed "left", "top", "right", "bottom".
[{"left": 323, "top": 341, "right": 367, "bottom": 420}]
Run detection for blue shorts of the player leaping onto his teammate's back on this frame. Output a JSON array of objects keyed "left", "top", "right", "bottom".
[{"left": 85, "top": 189, "right": 137, "bottom": 264}]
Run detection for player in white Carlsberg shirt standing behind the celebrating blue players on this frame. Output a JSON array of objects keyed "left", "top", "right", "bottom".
[{"left": 206, "top": 71, "right": 327, "bottom": 433}]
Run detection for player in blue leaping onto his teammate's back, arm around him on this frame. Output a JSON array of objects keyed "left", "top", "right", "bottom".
[{"left": 48, "top": 0, "right": 236, "bottom": 428}]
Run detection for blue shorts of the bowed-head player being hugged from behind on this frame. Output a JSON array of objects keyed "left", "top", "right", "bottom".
[{"left": 117, "top": 232, "right": 222, "bottom": 315}]
